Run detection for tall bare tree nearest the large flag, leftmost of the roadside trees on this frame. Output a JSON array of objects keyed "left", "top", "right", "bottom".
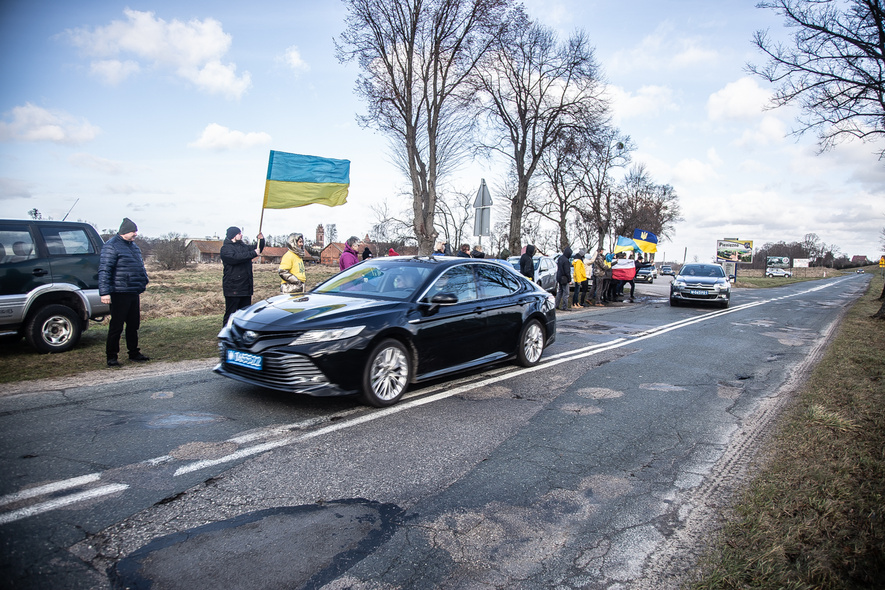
[{"left": 336, "top": 0, "right": 509, "bottom": 254}]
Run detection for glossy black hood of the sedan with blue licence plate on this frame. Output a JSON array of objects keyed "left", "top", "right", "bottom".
[{"left": 235, "top": 293, "right": 405, "bottom": 331}]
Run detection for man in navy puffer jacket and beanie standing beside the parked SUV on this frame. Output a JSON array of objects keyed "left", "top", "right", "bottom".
[{"left": 98, "top": 217, "right": 151, "bottom": 367}]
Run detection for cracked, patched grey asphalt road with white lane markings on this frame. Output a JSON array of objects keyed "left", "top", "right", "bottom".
[{"left": 0, "top": 275, "right": 868, "bottom": 589}]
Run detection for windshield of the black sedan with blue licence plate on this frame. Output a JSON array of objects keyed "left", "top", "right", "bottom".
[{"left": 312, "top": 261, "right": 431, "bottom": 300}]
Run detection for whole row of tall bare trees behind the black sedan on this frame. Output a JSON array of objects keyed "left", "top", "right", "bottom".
[{"left": 336, "top": 0, "right": 679, "bottom": 253}]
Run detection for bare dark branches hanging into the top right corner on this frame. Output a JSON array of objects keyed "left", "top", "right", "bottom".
[{"left": 748, "top": 0, "right": 885, "bottom": 160}]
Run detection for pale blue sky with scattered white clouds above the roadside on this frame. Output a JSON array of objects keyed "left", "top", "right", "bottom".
[{"left": 0, "top": 0, "right": 885, "bottom": 260}]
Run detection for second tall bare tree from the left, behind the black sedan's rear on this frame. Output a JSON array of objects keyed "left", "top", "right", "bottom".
[{"left": 476, "top": 7, "right": 608, "bottom": 252}]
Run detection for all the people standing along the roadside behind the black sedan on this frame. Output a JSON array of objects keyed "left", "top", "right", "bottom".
[{"left": 98, "top": 217, "right": 652, "bottom": 367}]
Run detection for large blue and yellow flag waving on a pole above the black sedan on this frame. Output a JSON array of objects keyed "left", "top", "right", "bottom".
[{"left": 264, "top": 150, "right": 350, "bottom": 209}]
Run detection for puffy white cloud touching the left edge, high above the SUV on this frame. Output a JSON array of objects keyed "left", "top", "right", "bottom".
[{"left": 0, "top": 103, "right": 100, "bottom": 144}]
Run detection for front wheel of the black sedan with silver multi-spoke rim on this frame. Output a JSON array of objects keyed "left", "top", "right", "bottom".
[{"left": 363, "top": 338, "right": 412, "bottom": 408}]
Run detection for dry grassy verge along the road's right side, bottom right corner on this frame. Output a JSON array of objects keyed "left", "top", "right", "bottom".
[{"left": 691, "top": 276, "right": 885, "bottom": 589}]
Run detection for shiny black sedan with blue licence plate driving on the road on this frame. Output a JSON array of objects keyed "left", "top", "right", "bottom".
[{"left": 214, "top": 256, "right": 556, "bottom": 407}]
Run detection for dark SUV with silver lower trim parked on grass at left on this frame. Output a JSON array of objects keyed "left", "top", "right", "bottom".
[{"left": 0, "top": 219, "right": 110, "bottom": 352}]
